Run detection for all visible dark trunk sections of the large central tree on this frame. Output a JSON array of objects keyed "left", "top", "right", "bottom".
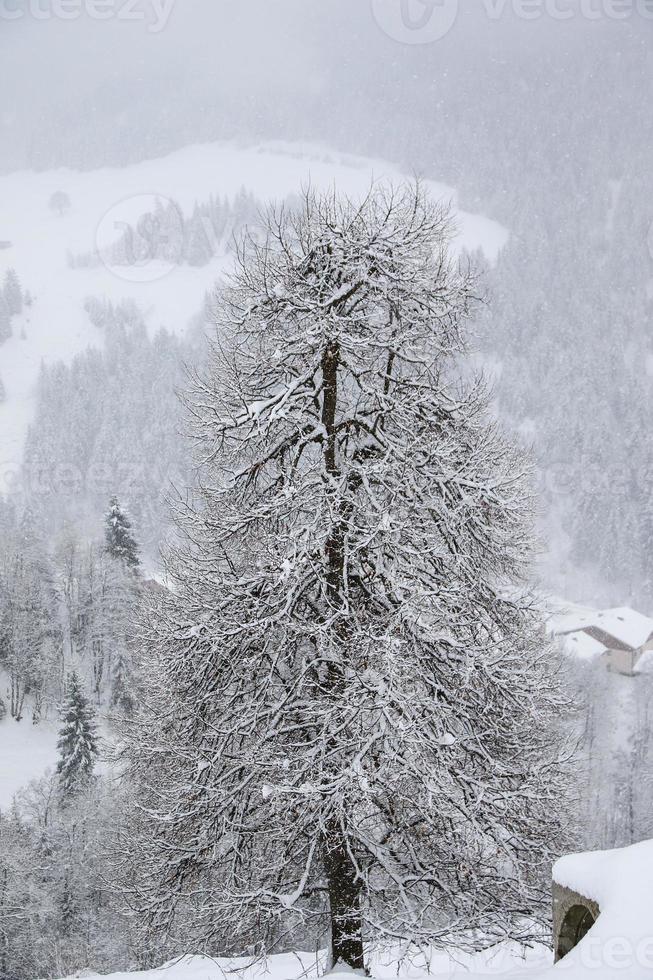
[{"left": 322, "top": 345, "right": 365, "bottom": 970}]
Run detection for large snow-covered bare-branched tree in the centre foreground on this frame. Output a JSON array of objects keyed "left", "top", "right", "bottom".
[{"left": 125, "top": 185, "right": 563, "bottom": 969}]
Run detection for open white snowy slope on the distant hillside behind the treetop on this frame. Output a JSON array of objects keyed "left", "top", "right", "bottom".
[{"left": 0, "top": 143, "right": 507, "bottom": 492}]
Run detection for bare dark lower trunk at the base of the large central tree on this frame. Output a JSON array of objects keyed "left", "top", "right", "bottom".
[{"left": 324, "top": 825, "right": 365, "bottom": 970}]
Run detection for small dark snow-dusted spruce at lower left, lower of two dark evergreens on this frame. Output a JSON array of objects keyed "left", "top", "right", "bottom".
[{"left": 57, "top": 671, "right": 98, "bottom": 796}]
